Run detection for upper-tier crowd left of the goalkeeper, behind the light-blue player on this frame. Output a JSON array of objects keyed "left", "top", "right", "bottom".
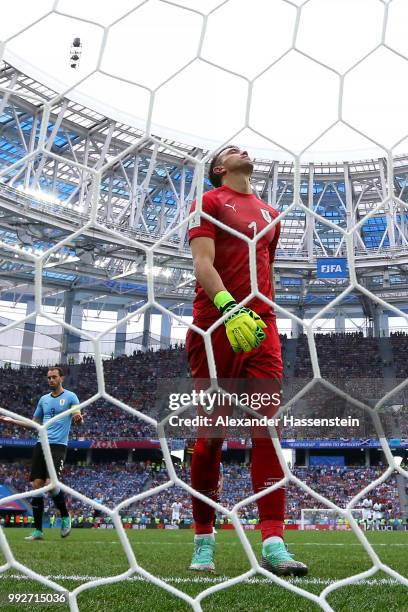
[{"left": 0, "top": 346, "right": 188, "bottom": 439}]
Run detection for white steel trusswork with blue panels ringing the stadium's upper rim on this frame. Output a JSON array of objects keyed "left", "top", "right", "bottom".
[{"left": 0, "top": 63, "right": 408, "bottom": 310}]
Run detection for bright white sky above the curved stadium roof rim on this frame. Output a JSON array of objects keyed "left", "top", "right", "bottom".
[{"left": 0, "top": 0, "right": 408, "bottom": 162}]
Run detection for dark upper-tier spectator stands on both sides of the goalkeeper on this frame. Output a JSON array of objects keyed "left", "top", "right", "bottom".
[{"left": 0, "top": 340, "right": 408, "bottom": 448}]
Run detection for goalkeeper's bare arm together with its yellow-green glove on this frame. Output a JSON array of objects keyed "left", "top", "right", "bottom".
[{"left": 191, "top": 237, "right": 266, "bottom": 353}]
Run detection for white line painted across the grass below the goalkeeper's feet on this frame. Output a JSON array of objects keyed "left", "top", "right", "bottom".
[{"left": 0, "top": 574, "right": 403, "bottom": 587}]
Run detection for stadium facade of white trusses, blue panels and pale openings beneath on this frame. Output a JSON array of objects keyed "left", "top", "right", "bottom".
[{"left": 0, "top": 63, "right": 408, "bottom": 364}]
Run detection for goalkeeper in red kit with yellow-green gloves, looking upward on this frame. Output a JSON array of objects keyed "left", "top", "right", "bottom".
[{"left": 186, "top": 145, "right": 307, "bottom": 576}]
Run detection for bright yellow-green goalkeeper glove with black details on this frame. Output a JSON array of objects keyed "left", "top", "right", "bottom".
[{"left": 214, "top": 291, "right": 266, "bottom": 353}]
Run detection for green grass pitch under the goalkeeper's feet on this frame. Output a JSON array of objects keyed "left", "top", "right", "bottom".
[{"left": 0, "top": 529, "right": 408, "bottom": 612}]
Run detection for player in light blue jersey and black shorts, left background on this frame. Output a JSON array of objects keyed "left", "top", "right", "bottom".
[{"left": 0, "top": 367, "right": 84, "bottom": 540}]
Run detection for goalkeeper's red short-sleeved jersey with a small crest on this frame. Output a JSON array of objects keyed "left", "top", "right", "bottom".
[{"left": 188, "top": 185, "right": 280, "bottom": 323}]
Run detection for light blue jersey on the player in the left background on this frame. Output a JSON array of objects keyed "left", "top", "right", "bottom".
[{"left": 34, "top": 389, "right": 79, "bottom": 445}]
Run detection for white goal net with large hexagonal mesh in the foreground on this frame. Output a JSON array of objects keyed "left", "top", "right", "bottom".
[{"left": 0, "top": 0, "right": 408, "bottom": 612}]
